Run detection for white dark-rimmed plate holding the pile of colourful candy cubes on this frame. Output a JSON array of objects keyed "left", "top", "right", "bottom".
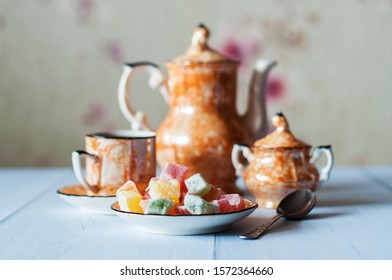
[{"left": 112, "top": 199, "right": 258, "bottom": 235}]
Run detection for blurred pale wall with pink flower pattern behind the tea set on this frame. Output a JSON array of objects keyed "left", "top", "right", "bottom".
[{"left": 0, "top": 0, "right": 392, "bottom": 166}]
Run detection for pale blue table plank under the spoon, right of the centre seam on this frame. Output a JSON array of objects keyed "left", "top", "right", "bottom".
[{"left": 216, "top": 168, "right": 392, "bottom": 259}]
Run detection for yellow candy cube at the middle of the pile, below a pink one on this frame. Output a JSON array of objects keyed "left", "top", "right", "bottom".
[{"left": 148, "top": 179, "right": 181, "bottom": 205}]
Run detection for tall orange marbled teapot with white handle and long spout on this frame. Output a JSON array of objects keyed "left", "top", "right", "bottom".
[{"left": 118, "top": 24, "right": 276, "bottom": 192}]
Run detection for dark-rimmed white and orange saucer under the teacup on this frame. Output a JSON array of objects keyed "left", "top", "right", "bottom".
[{"left": 57, "top": 185, "right": 117, "bottom": 215}]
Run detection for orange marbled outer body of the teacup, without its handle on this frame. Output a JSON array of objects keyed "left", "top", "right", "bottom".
[{"left": 86, "top": 136, "right": 156, "bottom": 195}]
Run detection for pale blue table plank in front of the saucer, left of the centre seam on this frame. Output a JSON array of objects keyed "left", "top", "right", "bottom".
[{"left": 0, "top": 171, "right": 214, "bottom": 259}]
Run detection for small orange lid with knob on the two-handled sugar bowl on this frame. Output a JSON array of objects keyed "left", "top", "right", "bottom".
[{"left": 254, "top": 112, "right": 310, "bottom": 148}]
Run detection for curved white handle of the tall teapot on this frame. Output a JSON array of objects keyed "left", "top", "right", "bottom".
[{"left": 117, "top": 62, "right": 168, "bottom": 131}]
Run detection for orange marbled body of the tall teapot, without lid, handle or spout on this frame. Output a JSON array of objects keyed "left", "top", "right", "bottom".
[{"left": 157, "top": 62, "right": 252, "bottom": 193}]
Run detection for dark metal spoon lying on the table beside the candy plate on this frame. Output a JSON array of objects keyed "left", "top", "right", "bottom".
[{"left": 239, "top": 189, "right": 316, "bottom": 239}]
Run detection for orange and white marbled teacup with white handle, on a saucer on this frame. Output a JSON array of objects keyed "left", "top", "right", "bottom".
[{"left": 72, "top": 130, "right": 156, "bottom": 196}]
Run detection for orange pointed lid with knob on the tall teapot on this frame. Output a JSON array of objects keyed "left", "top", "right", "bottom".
[{"left": 172, "top": 24, "right": 239, "bottom": 64}]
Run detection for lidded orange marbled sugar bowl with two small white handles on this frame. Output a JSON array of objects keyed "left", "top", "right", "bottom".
[{"left": 232, "top": 113, "right": 333, "bottom": 208}]
